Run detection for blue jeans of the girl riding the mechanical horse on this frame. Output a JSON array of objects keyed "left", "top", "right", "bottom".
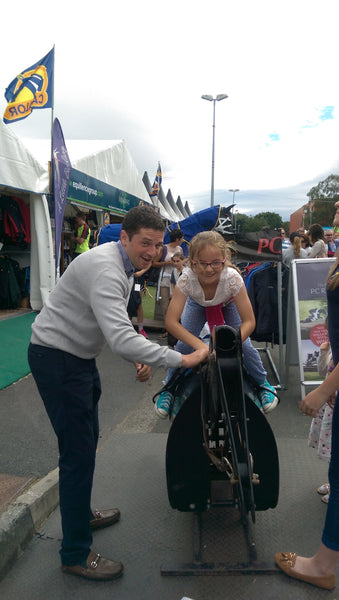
[{"left": 175, "top": 297, "right": 267, "bottom": 384}]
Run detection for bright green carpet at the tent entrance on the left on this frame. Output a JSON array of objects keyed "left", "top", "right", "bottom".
[{"left": 0, "top": 312, "right": 37, "bottom": 390}]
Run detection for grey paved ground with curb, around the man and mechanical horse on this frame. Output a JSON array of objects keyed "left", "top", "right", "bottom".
[{"left": 0, "top": 332, "right": 336, "bottom": 600}]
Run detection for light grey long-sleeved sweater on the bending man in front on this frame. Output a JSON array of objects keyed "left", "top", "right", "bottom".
[{"left": 31, "top": 242, "right": 182, "bottom": 367}]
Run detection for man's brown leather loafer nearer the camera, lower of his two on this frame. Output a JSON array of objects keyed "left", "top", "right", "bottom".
[{"left": 61, "top": 551, "right": 124, "bottom": 581}]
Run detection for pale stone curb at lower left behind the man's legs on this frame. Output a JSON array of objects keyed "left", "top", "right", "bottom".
[{"left": 0, "top": 468, "right": 59, "bottom": 580}]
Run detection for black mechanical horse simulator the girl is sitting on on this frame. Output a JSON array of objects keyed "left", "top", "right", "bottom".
[{"left": 161, "top": 325, "right": 279, "bottom": 575}]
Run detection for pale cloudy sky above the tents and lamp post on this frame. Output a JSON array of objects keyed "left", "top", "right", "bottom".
[{"left": 0, "top": 0, "right": 339, "bottom": 220}]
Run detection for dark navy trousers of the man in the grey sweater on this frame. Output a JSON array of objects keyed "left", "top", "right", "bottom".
[{"left": 28, "top": 344, "right": 101, "bottom": 566}]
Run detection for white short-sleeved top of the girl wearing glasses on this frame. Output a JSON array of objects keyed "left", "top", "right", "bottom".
[{"left": 177, "top": 267, "right": 244, "bottom": 306}]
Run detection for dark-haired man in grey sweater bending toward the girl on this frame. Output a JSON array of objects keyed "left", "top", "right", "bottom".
[{"left": 28, "top": 206, "right": 207, "bottom": 580}]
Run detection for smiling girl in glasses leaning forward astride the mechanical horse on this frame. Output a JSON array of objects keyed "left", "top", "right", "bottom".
[{"left": 155, "top": 231, "right": 278, "bottom": 418}]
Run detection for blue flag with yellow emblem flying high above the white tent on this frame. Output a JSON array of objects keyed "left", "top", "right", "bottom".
[{"left": 3, "top": 48, "right": 54, "bottom": 123}]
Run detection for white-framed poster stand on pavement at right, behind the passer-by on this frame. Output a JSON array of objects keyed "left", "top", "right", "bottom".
[{"left": 285, "top": 258, "right": 335, "bottom": 398}]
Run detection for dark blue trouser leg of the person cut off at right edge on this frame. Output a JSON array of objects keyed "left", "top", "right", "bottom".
[{"left": 321, "top": 392, "right": 339, "bottom": 551}]
